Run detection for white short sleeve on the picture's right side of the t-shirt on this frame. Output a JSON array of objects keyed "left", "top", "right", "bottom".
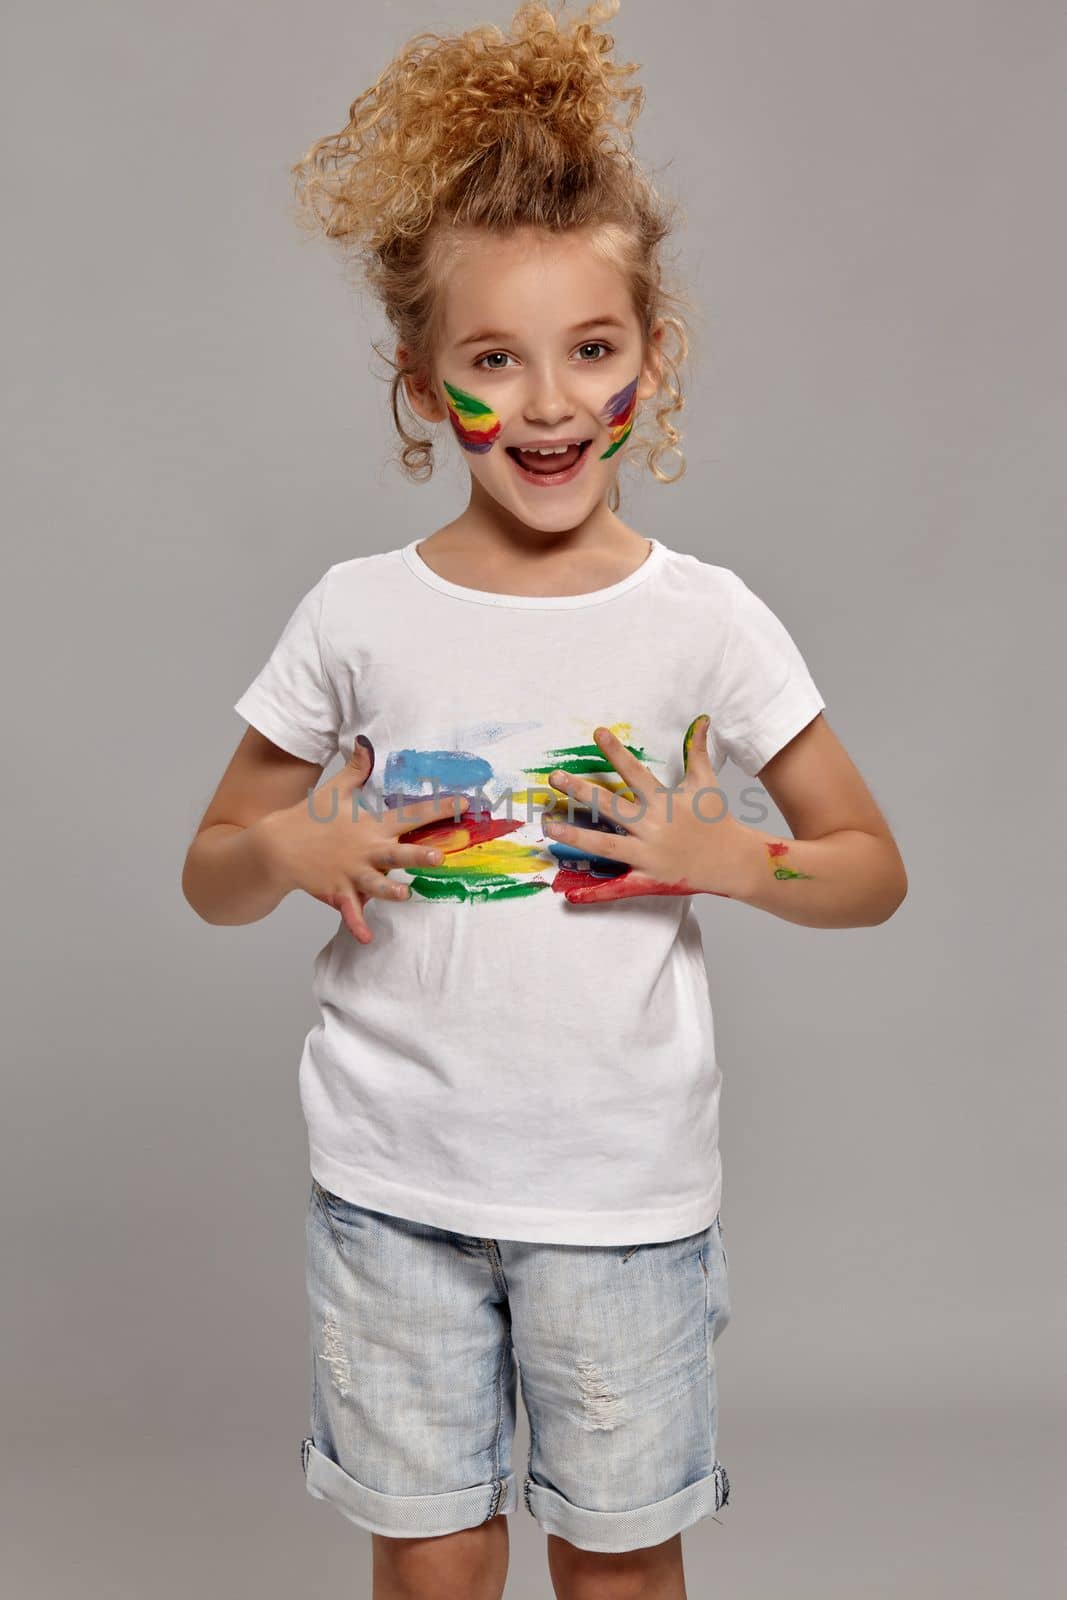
[{"left": 709, "top": 573, "right": 825, "bottom": 778}]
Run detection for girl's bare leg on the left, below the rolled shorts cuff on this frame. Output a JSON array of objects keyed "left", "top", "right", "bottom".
[{"left": 371, "top": 1517, "right": 509, "bottom": 1600}]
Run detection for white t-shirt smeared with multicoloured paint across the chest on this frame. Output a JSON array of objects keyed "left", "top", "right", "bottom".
[{"left": 235, "top": 539, "right": 825, "bottom": 1245}]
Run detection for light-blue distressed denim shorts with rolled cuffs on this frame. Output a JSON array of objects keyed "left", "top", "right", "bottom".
[{"left": 301, "top": 1178, "right": 729, "bottom": 1550}]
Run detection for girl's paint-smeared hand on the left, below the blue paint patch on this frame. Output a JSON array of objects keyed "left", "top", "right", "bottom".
[{"left": 264, "top": 734, "right": 469, "bottom": 944}]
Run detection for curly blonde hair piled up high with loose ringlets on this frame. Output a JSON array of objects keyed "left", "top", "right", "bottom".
[{"left": 291, "top": 0, "right": 689, "bottom": 510}]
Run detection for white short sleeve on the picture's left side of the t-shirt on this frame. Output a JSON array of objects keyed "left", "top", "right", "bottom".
[{"left": 234, "top": 571, "right": 341, "bottom": 766}]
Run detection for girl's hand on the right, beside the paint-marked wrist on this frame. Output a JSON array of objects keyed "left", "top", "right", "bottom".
[{"left": 541, "top": 715, "right": 752, "bottom": 906}]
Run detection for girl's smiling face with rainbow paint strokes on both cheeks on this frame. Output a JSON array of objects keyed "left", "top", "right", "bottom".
[{"left": 398, "top": 229, "right": 657, "bottom": 533}]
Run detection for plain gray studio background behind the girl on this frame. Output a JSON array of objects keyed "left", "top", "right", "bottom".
[{"left": 0, "top": 0, "right": 1067, "bottom": 1600}]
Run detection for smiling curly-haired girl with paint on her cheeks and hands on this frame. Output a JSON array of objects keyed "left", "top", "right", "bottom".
[{"left": 184, "top": 0, "right": 905, "bottom": 1600}]
